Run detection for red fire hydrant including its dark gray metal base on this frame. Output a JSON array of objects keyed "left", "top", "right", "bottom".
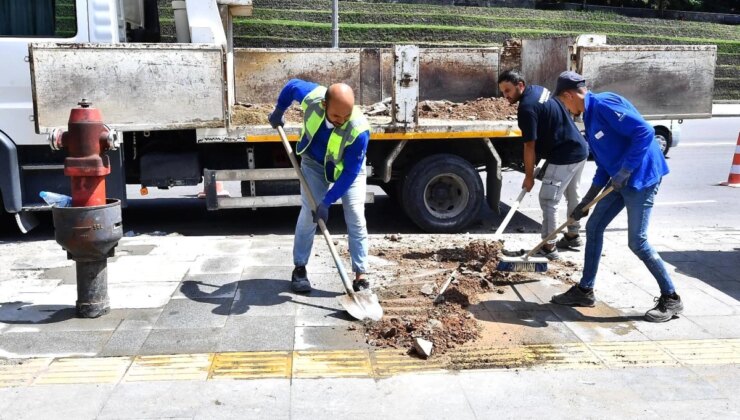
[{"left": 49, "top": 99, "right": 123, "bottom": 318}]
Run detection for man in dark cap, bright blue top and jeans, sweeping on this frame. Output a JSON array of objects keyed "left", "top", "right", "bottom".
[{"left": 552, "top": 71, "right": 683, "bottom": 322}]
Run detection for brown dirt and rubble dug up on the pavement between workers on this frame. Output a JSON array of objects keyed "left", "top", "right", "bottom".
[{"left": 364, "top": 235, "right": 576, "bottom": 357}]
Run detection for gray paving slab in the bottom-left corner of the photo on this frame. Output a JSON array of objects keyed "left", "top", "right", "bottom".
[{"left": 0, "top": 384, "right": 115, "bottom": 420}]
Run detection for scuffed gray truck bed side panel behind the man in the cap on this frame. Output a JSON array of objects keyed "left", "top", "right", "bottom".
[{"left": 578, "top": 45, "right": 717, "bottom": 119}]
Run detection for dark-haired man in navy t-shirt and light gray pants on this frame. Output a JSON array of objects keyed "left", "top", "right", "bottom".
[{"left": 498, "top": 70, "right": 588, "bottom": 260}]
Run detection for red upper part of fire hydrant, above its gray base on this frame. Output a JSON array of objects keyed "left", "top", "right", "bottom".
[{"left": 50, "top": 99, "right": 119, "bottom": 207}]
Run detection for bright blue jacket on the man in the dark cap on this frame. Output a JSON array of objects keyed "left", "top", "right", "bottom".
[{"left": 583, "top": 92, "right": 669, "bottom": 190}]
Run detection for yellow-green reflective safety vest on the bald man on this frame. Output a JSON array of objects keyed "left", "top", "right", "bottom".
[{"left": 297, "top": 86, "right": 370, "bottom": 182}]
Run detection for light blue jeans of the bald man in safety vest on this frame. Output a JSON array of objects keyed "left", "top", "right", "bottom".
[{"left": 293, "top": 154, "right": 368, "bottom": 273}]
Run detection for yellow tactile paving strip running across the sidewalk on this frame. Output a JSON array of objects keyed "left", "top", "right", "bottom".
[{"left": 0, "top": 339, "right": 740, "bottom": 387}]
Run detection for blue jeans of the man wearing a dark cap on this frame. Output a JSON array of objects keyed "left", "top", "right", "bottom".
[{"left": 580, "top": 182, "right": 675, "bottom": 294}]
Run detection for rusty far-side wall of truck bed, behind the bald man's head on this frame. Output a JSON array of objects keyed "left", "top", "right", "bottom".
[{"left": 234, "top": 48, "right": 500, "bottom": 105}]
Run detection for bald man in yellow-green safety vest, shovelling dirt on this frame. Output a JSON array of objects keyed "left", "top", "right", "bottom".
[{"left": 268, "top": 79, "right": 370, "bottom": 292}]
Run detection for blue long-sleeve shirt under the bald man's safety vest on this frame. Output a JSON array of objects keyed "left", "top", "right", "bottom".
[{"left": 277, "top": 79, "right": 370, "bottom": 205}]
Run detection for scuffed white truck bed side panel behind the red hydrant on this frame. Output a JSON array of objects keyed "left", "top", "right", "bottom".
[{"left": 30, "top": 43, "right": 226, "bottom": 133}]
